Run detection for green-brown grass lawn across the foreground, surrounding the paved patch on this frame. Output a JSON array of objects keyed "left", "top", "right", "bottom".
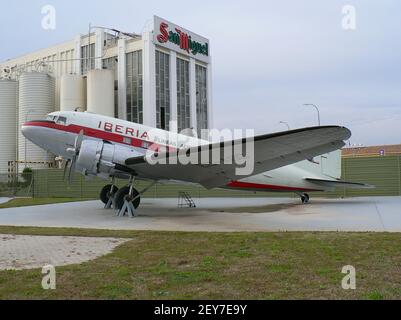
[{"left": 0, "top": 227, "right": 401, "bottom": 299}]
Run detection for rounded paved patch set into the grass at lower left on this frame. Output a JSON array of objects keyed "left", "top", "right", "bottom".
[{"left": 0, "top": 234, "right": 128, "bottom": 270}]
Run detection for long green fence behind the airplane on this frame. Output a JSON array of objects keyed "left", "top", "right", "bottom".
[{"left": 0, "top": 156, "right": 401, "bottom": 199}]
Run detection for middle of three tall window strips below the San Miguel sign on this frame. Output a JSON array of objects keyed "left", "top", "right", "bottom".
[{"left": 177, "top": 58, "right": 191, "bottom": 132}]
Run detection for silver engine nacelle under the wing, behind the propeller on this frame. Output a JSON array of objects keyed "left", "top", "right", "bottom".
[{"left": 76, "top": 140, "right": 133, "bottom": 178}]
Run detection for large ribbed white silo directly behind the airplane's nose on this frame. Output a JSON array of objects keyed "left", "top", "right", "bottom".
[{"left": 18, "top": 72, "right": 55, "bottom": 172}]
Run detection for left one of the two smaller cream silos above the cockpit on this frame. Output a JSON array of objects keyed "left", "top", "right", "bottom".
[{"left": 60, "top": 74, "right": 86, "bottom": 111}]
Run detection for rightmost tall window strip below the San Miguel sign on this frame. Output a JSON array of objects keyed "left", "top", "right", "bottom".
[{"left": 196, "top": 65, "right": 208, "bottom": 137}]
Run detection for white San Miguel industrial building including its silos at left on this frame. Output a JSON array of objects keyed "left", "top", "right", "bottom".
[{"left": 0, "top": 16, "right": 213, "bottom": 173}]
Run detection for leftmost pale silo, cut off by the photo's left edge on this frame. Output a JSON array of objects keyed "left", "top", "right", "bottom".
[{"left": 0, "top": 79, "right": 18, "bottom": 174}]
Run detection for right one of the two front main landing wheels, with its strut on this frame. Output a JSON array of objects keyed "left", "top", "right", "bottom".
[{"left": 114, "top": 176, "right": 141, "bottom": 218}]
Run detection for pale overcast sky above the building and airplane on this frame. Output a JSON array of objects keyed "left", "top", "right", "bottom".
[{"left": 0, "top": 0, "right": 401, "bottom": 145}]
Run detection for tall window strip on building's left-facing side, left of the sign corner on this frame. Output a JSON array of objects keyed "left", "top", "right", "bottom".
[{"left": 127, "top": 51, "right": 143, "bottom": 124}]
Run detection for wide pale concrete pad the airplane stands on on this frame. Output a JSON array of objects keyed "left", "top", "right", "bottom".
[{"left": 0, "top": 197, "right": 401, "bottom": 232}]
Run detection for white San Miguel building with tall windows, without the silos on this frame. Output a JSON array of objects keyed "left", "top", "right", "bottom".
[{"left": 0, "top": 17, "right": 213, "bottom": 170}]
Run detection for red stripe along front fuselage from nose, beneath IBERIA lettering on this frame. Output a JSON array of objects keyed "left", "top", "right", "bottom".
[{"left": 23, "top": 121, "right": 176, "bottom": 152}]
